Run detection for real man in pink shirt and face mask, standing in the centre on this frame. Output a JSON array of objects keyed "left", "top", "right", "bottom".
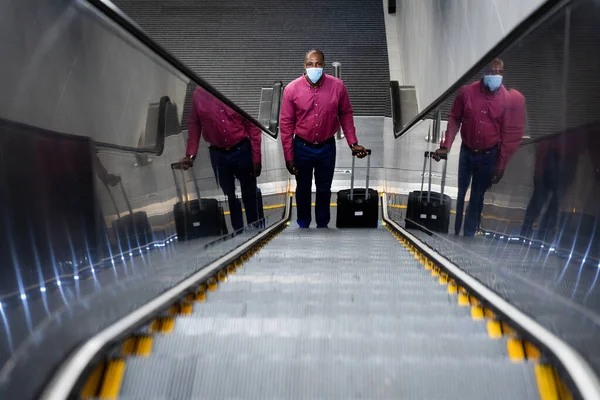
[{"left": 279, "top": 50, "right": 367, "bottom": 228}]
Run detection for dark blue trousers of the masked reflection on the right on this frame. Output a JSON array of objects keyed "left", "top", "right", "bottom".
[{"left": 454, "top": 146, "right": 498, "bottom": 236}]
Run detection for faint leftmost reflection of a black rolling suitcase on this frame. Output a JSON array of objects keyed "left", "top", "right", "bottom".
[{"left": 105, "top": 179, "right": 153, "bottom": 251}]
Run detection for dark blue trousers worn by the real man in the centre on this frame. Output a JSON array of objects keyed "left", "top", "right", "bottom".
[{"left": 294, "top": 140, "right": 336, "bottom": 228}]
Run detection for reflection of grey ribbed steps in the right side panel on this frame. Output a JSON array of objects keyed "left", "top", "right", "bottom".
[{"left": 411, "top": 227, "right": 600, "bottom": 380}]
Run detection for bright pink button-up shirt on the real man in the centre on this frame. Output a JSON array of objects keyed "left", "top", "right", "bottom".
[{"left": 279, "top": 74, "right": 358, "bottom": 161}]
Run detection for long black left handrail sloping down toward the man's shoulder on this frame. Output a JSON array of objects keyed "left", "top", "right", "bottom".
[{"left": 87, "top": 0, "right": 277, "bottom": 142}]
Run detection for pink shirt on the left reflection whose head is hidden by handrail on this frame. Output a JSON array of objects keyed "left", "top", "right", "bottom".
[{"left": 186, "top": 87, "right": 262, "bottom": 163}]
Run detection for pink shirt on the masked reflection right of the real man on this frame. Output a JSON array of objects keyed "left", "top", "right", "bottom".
[{"left": 441, "top": 81, "right": 524, "bottom": 169}]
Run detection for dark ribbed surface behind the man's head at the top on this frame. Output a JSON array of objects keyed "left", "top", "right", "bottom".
[{"left": 114, "top": 0, "right": 391, "bottom": 117}]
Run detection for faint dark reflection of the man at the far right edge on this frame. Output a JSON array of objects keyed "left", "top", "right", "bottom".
[{"left": 521, "top": 123, "right": 598, "bottom": 240}]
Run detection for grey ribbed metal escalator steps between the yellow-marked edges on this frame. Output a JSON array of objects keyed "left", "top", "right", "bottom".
[{"left": 120, "top": 228, "right": 537, "bottom": 399}]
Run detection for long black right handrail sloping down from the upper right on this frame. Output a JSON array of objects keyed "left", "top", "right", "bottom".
[{"left": 394, "top": 0, "right": 572, "bottom": 139}]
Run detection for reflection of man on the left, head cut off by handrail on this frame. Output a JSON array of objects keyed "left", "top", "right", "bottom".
[{"left": 183, "top": 87, "right": 262, "bottom": 230}]
